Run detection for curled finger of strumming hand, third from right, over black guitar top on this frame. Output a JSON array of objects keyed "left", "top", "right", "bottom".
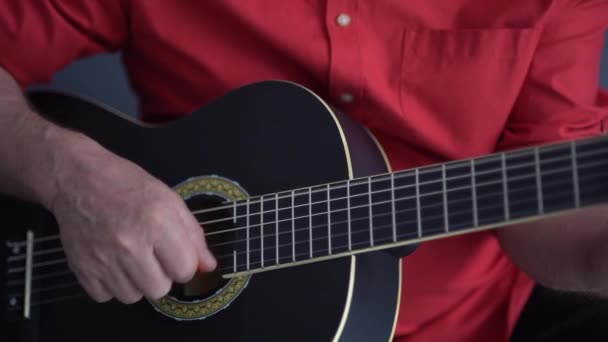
[{"left": 121, "top": 251, "right": 171, "bottom": 299}]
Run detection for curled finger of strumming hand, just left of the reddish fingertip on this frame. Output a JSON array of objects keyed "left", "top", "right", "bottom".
[{"left": 154, "top": 228, "right": 198, "bottom": 283}]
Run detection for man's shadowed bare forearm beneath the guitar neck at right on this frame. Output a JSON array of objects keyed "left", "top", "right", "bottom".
[{"left": 498, "top": 204, "right": 608, "bottom": 296}]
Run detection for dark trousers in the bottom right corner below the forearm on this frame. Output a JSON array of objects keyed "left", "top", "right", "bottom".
[{"left": 511, "top": 285, "right": 608, "bottom": 342}]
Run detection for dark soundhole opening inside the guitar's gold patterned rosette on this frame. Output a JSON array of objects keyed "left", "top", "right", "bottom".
[{"left": 169, "top": 195, "right": 235, "bottom": 301}]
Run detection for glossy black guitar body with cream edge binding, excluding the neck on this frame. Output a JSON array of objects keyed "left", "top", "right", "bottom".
[{"left": 0, "top": 82, "right": 401, "bottom": 342}]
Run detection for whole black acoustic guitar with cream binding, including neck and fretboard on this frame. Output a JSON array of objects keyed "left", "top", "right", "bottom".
[{"left": 0, "top": 81, "right": 608, "bottom": 342}]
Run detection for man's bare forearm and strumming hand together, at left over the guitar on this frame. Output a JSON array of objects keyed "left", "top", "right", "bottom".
[{"left": 0, "top": 68, "right": 215, "bottom": 303}]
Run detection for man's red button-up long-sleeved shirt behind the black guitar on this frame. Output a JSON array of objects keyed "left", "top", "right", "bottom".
[{"left": 0, "top": 0, "right": 608, "bottom": 341}]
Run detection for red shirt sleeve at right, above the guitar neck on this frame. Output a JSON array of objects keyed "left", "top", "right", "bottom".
[{"left": 497, "top": 0, "right": 608, "bottom": 150}]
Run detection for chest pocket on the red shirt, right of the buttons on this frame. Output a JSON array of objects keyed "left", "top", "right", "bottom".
[{"left": 399, "top": 29, "right": 539, "bottom": 145}]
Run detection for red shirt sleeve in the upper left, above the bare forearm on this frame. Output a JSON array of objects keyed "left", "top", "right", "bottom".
[{"left": 0, "top": 0, "right": 128, "bottom": 87}]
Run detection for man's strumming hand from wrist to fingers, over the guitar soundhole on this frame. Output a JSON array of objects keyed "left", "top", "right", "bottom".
[{"left": 43, "top": 132, "right": 216, "bottom": 303}]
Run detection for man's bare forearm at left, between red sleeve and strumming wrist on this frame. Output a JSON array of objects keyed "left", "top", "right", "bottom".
[{"left": 0, "top": 68, "right": 84, "bottom": 206}]
